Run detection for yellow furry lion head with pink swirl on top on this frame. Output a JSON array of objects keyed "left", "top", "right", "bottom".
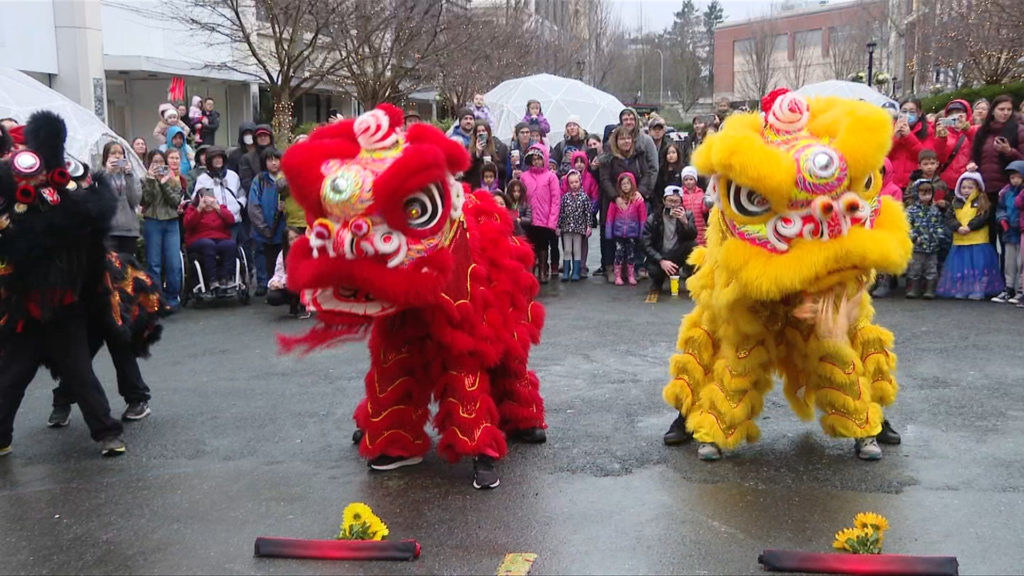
[{"left": 693, "top": 90, "right": 912, "bottom": 299}]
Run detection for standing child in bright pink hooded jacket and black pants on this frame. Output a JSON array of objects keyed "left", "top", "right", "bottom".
[{"left": 519, "top": 143, "right": 562, "bottom": 284}]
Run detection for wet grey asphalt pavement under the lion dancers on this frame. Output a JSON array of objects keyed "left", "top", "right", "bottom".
[{"left": 0, "top": 270, "right": 1024, "bottom": 574}]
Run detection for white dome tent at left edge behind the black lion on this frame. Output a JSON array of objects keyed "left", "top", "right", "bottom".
[{"left": 0, "top": 67, "right": 145, "bottom": 174}]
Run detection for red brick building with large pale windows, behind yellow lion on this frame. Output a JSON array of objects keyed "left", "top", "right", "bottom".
[{"left": 714, "top": 0, "right": 889, "bottom": 101}]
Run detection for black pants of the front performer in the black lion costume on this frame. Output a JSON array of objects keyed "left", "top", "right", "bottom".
[{"left": 0, "top": 304, "right": 123, "bottom": 447}]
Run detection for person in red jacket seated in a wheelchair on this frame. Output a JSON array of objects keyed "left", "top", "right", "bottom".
[{"left": 185, "top": 188, "right": 238, "bottom": 290}]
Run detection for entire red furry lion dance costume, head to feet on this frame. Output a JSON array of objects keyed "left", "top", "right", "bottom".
[{"left": 282, "top": 105, "right": 547, "bottom": 488}]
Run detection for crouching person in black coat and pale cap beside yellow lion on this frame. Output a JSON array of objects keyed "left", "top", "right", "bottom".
[{"left": 640, "top": 186, "right": 697, "bottom": 294}]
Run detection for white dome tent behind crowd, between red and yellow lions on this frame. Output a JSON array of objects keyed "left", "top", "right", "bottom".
[{"left": 483, "top": 74, "right": 626, "bottom": 142}]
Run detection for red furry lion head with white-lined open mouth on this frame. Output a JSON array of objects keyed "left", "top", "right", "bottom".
[{"left": 282, "top": 104, "right": 469, "bottom": 334}]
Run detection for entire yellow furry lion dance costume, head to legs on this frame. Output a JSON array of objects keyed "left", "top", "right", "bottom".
[{"left": 664, "top": 89, "right": 912, "bottom": 460}]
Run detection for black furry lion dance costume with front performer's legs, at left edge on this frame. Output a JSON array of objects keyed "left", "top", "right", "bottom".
[{"left": 0, "top": 112, "right": 163, "bottom": 456}]
